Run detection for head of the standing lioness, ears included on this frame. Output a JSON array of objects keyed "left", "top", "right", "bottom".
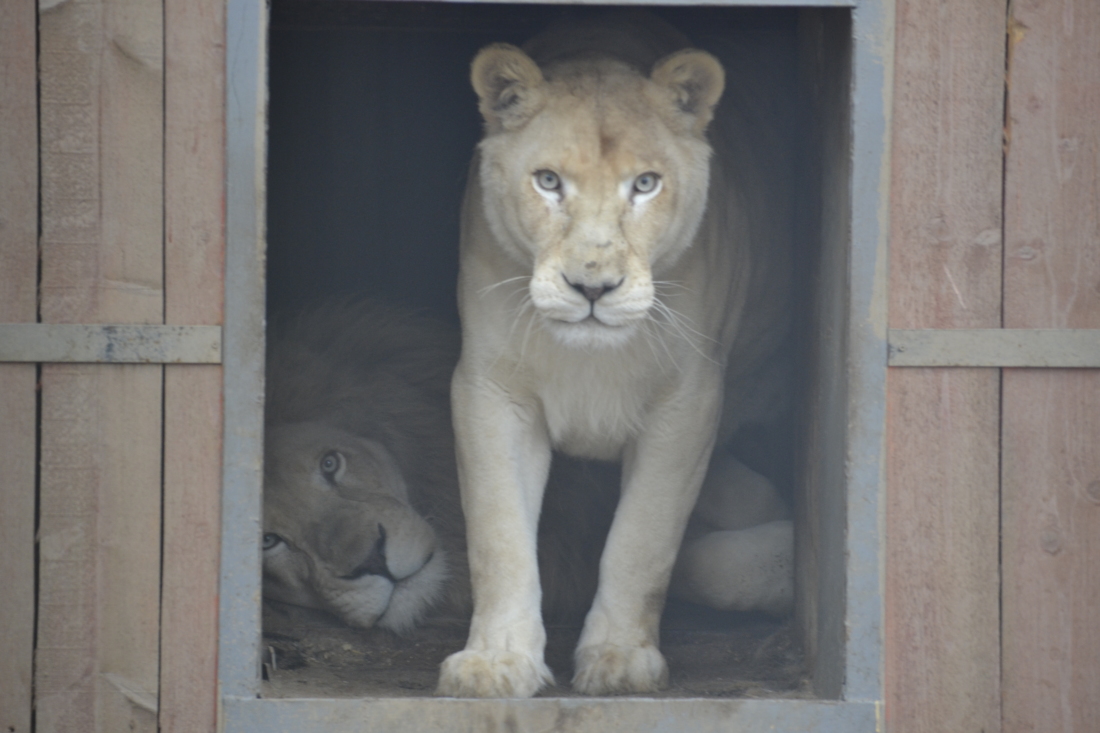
[{"left": 473, "top": 46, "right": 723, "bottom": 346}]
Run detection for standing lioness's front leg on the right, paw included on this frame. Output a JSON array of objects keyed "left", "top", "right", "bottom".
[{"left": 573, "top": 387, "right": 714, "bottom": 694}]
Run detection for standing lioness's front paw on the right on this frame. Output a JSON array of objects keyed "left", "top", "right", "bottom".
[{"left": 573, "top": 644, "right": 669, "bottom": 694}]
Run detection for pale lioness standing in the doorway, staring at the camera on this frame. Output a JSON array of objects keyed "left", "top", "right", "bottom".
[{"left": 438, "top": 17, "right": 793, "bottom": 697}]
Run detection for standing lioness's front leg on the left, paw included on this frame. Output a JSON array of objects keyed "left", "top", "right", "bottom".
[{"left": 437, "top": 368, "right": 553, "bottom": 698}]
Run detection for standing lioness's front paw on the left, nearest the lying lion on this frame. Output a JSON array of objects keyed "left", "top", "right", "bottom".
[{"left": 436, "top": 650, "right": 553, "bottom": 698}]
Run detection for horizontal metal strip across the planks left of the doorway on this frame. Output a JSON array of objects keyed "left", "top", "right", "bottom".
[{"left": 0, "top": 324, "right": 221, "bottom": 364}]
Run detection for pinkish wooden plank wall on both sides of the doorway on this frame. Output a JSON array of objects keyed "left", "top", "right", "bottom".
[{"left": 0, "top": 0, "right": 1100, "bottom": 733}]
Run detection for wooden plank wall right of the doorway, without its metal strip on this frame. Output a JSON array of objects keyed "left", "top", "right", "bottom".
[{"left": 886, "top": 0, "right": 1100, "bottom": 733}]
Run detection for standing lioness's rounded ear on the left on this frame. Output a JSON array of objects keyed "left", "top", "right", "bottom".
[{"left": 470, "top": 43, "right": 542, "bottom": 131}]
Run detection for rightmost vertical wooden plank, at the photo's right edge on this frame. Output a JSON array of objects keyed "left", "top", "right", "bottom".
[{"left": 1002, "top": 0, "right": 1100, "bottom": 733}]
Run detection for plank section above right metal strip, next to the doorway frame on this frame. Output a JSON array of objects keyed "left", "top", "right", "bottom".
[{"left": 890, "top": 0, "right": 1004, "bottom": 328}]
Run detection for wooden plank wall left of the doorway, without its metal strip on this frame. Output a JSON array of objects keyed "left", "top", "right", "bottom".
[{"left": 0, "top": 0, "right": 224, "bottom": 733}]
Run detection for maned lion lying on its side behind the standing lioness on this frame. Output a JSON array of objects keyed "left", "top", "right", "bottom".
[{"left": 263, "top": 300, "right": 790, "bottom": 633}]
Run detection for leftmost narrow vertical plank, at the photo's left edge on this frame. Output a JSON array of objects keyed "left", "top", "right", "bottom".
[{"left": 0, "top": 0, "right": 39, "bottom": 733}]
